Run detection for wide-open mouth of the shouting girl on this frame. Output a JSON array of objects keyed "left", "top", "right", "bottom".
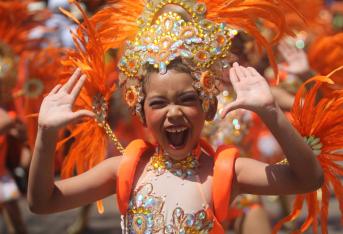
[{"left": 165, "top": 127, "right": 189, "bottom": 149}]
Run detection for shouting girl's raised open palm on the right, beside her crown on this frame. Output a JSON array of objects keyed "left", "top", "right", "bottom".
[{"left": 221, "top": 63, "right": 275, "bottom": 118}]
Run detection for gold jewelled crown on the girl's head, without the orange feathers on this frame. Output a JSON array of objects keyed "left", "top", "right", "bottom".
[{"left": 118, "top": 0, "right": 237, "bottom": 117}]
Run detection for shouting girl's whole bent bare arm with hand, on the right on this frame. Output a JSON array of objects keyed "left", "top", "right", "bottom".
[{"left": 222, "top": 64, "right": 323, "bottom": 197}]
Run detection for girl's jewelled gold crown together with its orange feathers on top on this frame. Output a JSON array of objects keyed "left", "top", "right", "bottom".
[{"left": 91, "top": 0, "right": 304, "bottom": 115}]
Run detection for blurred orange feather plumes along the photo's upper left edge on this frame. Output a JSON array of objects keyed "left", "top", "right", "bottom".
[{"left": 0, "top": 0, "right": 50, "bottom": 122}]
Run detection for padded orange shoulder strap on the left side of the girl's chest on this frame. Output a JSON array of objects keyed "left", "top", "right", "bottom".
[{"left": 116, "top": 140, "right": 151, "bottom": 214}]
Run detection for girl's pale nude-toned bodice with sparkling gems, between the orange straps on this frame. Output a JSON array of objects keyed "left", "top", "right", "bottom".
[{"left": 123, "top": 157, "right": 213, "bottom": 234}]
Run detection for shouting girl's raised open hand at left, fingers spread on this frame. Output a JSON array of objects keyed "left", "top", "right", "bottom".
[{"left": 38, "top": 69, "right": 95, "bottom": 131}]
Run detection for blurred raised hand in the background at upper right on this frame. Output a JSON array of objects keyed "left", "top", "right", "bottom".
[{"left": 278, "top": 38, "right": 310, "bottom": 75}]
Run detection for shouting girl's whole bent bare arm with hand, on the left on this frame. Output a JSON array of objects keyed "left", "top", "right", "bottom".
[{"left": 28, "top": 71, "right": 120, "bottom": 213}]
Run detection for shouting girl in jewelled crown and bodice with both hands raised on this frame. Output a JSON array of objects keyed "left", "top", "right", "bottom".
[{"left": 28, "top": 1, "right": 330, "bottom": 233}]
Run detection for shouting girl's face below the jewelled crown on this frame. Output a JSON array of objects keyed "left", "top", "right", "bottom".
[{"left": 144, "top": 70, "right": 205, "bottom": 160}]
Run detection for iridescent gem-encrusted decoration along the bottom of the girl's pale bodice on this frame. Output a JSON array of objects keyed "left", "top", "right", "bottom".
[{"left": 127, "top": 183, "right": 213, "bottom": 234}]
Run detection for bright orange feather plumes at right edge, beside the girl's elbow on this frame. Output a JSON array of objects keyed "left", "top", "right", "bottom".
[{"left": 273, "top": 70, "right": 343, "bottom": 233}]
